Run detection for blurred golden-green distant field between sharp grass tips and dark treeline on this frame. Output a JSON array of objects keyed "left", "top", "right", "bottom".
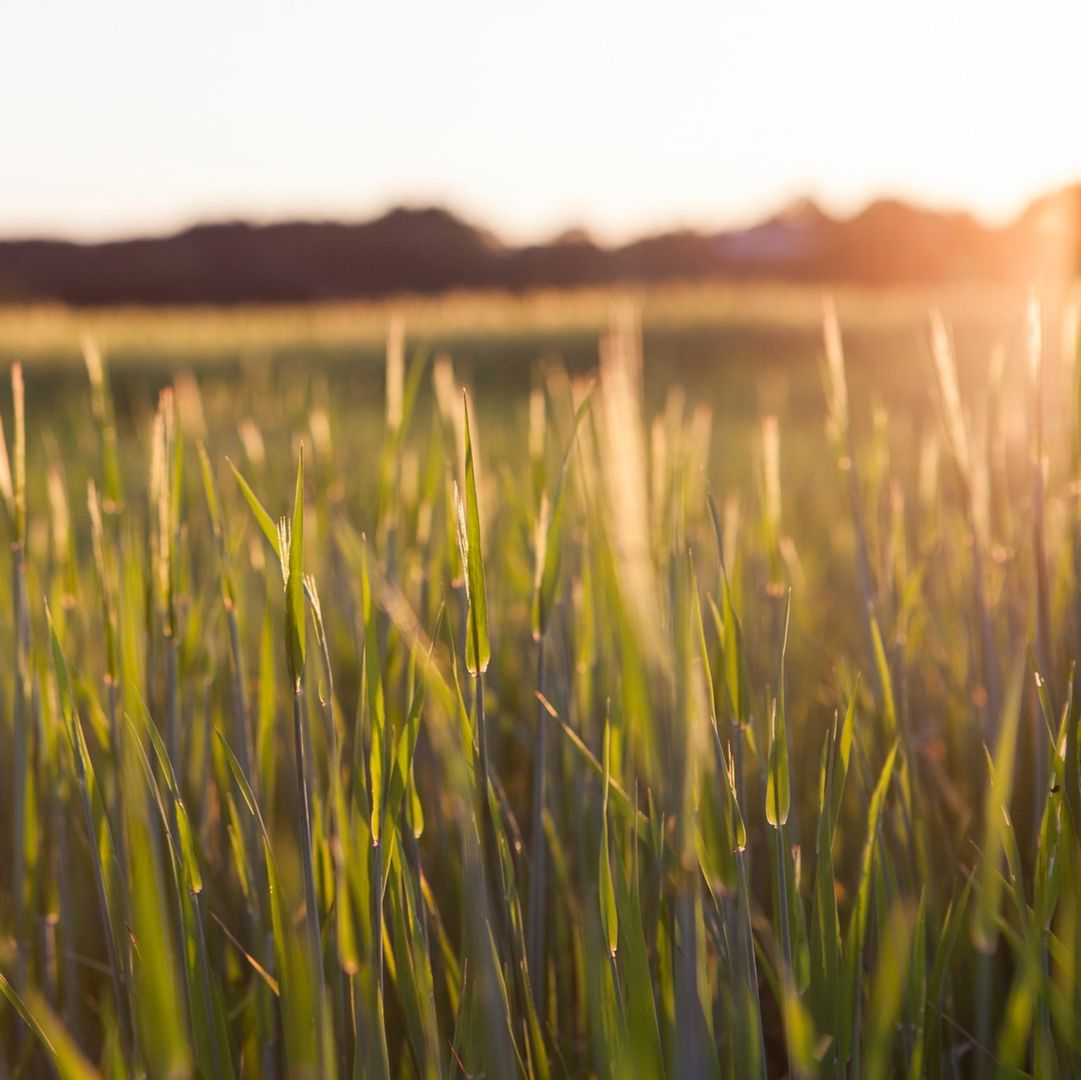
[{"left": 0, "top": 284, "right": 1050, "bottom": 464}]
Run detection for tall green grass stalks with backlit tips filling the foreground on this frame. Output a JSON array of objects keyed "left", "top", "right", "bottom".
[{"left": 0, "top": 291, "right": 1081, "bottom": 1077}]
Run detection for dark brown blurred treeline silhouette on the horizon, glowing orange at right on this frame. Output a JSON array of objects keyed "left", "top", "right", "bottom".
[{"left": 0, "top": 184, "right": 1081, "bottom": 306}]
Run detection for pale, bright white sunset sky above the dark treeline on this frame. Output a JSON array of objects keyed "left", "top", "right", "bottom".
[{"left": 0, "top": 0, "right": 1081, "bottom": 242}]
